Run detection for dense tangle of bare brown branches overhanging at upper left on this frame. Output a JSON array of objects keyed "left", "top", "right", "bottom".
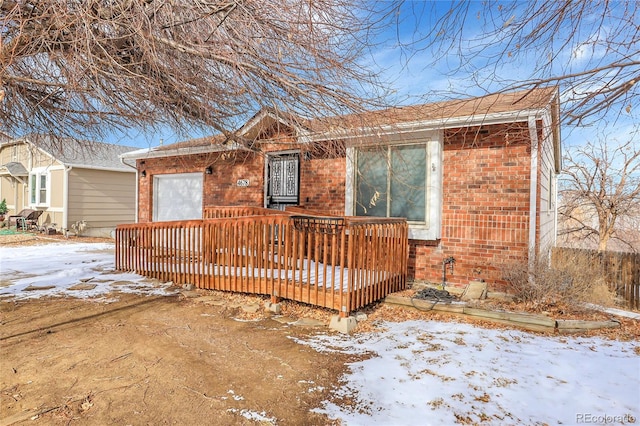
[{"left": 0, "top": 0, "right": 392, "bottom": 144}]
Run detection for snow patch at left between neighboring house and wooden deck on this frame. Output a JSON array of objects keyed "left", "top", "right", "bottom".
[{"left": 0, "top": 243, "right": 176, "bottom": 299}]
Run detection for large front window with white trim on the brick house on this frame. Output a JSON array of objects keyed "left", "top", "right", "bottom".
[{"left": 347, "top": 139, "right": 442, "bottom": 240}]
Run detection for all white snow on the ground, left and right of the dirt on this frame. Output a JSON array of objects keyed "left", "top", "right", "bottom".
[{"left": 0, "top": 243, "right": 640, "bottom": 425}]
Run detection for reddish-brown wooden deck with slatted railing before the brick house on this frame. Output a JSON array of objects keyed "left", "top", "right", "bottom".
[{"left": 116, "top": 207, "right": 408, "bottom": 315}]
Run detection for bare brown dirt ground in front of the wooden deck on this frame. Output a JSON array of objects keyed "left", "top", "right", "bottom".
[{"left": 0, "top": 235, "right": 640, "bottom": 426}]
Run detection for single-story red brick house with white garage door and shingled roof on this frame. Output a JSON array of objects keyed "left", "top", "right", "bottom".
[{"left": 122, "top": 88, "right": 561, "bottom": 288}]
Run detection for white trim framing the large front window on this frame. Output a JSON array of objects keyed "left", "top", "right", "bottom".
[{"left": 345, "top": 131, "right": 444, "bottom": 240}]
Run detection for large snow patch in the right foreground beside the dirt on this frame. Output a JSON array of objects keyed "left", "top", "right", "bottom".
[{"left": 300, "top": 321, "right": 640, "bottom": 425}]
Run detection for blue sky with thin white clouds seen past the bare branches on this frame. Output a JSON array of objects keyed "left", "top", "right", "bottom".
[{"left": 110, "top": 1, "right": 640, "bottom": 148}]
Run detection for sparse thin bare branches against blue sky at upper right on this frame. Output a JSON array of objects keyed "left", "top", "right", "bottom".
[{"left": 397, "top": 0, "right": 640, "bottom": 124}]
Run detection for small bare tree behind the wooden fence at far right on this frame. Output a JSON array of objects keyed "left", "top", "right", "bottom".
[{"left": 558, "top": 140, "right": 640, "bottom": 251}]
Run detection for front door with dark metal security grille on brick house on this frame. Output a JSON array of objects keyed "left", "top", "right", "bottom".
[{"left": 267, "top": 153, "right": 300, "bottom": 210}]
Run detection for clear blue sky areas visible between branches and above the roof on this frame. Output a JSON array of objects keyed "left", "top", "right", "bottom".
[{"left": 108, "top": 1, "right": 640, "bottom": 148}]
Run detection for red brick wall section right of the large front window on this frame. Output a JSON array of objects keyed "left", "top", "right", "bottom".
[{"left": 409, "top": 123, "right": 531, "bottom": 288}]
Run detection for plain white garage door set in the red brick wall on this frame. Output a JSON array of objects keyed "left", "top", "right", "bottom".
[{"left": 153, "top": 173, "right": 202, "bottom": 222}]
